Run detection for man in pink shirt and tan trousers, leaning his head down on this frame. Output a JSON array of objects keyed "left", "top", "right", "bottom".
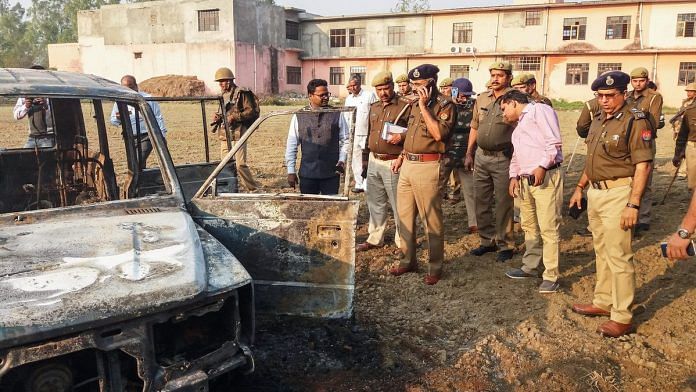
[{"left": 501, "top": 90, "right": 563, "bottom": 293}]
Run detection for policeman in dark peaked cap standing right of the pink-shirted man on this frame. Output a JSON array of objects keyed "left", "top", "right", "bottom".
[{"left": 569, "top": 71, "right": 655, "bottom": 337}]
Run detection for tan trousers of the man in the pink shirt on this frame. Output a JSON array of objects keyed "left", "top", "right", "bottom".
[{"left": 515, "top": 168, "right": 563, "bottom": 282}]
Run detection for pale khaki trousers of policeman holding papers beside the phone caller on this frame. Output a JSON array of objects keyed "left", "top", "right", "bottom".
[{"left": 366, "top": 154, "right": 401, "bottom": 247}]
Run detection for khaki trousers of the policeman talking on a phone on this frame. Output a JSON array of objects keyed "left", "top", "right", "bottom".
[{"left": 396, "top": 160, "right": 445, "bottom": 277}]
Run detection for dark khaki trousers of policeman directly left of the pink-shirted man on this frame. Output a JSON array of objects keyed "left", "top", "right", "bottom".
[{"left": 474, "top": 148, "right": 514, "bottom": 250}]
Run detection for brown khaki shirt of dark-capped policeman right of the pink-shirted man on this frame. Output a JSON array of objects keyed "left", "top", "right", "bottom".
[{"left": 585, "top": 104, "right": 655, "bottom": 181}]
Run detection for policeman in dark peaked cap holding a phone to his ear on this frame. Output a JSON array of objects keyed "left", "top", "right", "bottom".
[{"left": 389, "top": 64, "right": 454, "bottom": 285}]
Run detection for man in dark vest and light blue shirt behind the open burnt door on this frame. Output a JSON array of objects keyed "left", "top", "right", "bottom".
[{"left": 285, "top": 79, "right": 349, "bottom": 195}]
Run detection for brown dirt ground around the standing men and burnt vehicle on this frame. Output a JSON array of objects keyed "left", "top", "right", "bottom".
[{"left": 0, "top": 104, "right": 696, "bottom": 391}]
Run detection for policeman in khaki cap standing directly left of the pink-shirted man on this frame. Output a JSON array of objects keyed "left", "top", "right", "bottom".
[{"left": 465, "top": 62, "right": 515, "bottom": 262}]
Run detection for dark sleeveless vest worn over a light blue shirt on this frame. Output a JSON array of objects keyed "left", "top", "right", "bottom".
[{"left": 297, "top": 108, "right": 341, "bottom": 179}]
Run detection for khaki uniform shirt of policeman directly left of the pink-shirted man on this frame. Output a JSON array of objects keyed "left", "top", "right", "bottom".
[{"left": 471, "top": 87, "right": 516, "bottom": 151}]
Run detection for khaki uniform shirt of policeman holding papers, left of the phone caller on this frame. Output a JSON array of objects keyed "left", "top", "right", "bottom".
[{"left": 363, "top": 94, "right": 411, "bottom": 160}]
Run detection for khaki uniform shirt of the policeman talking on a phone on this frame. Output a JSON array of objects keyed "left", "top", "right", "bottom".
[{"left": 404, "top": 92, "right": 455, "bottom": 154}]
